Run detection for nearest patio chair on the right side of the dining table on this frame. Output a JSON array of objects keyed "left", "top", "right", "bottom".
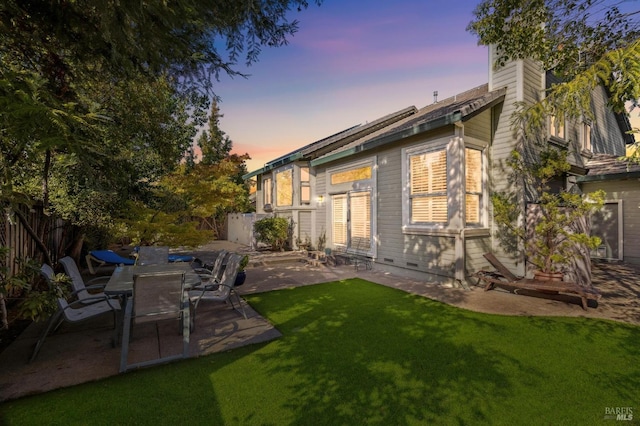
[{"left": 189, "top": 254, "right": 247, "bottom": 327}]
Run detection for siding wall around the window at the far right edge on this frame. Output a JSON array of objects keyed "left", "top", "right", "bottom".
[{"left": 582, "top": 180, "right": 640, "bottom": 264}]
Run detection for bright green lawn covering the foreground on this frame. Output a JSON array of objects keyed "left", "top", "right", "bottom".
[{"left": 0, "top": 279, "right": 640, "bottom": 425}]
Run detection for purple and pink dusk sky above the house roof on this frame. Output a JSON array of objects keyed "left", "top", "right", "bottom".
[{"left": 215, "top": 0, "right": 640, "bottom": 171}]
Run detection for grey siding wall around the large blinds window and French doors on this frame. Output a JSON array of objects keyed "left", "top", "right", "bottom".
[{"left": 316, "top": 124, "right": 492, "bottom": 284}]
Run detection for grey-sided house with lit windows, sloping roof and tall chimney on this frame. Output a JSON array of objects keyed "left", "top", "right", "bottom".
[{"left": 245, "top": 45, "right": 625, "bottom": 286}]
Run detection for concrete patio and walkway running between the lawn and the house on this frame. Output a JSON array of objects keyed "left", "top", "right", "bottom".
[{"left": 0, "top": 242, "right": 640, "bottom": 401}]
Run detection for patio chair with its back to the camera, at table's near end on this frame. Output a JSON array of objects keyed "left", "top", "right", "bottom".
[{"left": 120, "top": 272, "right": 190, "bottom": 373}]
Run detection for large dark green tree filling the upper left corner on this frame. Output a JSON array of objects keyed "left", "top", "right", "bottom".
[{"left": 0, "top": 0, "right": 319, "bottom": 261}]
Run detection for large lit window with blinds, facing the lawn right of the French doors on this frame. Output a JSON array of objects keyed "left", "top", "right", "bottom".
[{"left": 409, "top": 149, "right": 448, "bottom": 223}]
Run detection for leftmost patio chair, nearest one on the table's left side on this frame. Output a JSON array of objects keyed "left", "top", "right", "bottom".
[{"left": 29, "top": 264, "right": 120, "bottom": 362}]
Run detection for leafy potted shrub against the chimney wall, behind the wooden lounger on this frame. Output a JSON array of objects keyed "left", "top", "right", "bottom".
[{"left": 491, "top": 148, "right": 605, "bottom": 281}]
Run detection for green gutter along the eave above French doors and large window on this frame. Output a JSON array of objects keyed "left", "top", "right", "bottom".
[{"left": 311, "top": 111, "right": 462, "bottom": 167}]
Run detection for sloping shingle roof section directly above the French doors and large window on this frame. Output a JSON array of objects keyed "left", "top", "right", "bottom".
[{"left": 311, "top": 84, "right": 506, "bottom": 166}]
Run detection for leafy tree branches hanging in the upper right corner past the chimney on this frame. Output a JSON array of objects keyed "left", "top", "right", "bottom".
[{"left": 467, "top": 0, "right": 640, "bottom": 161}]
